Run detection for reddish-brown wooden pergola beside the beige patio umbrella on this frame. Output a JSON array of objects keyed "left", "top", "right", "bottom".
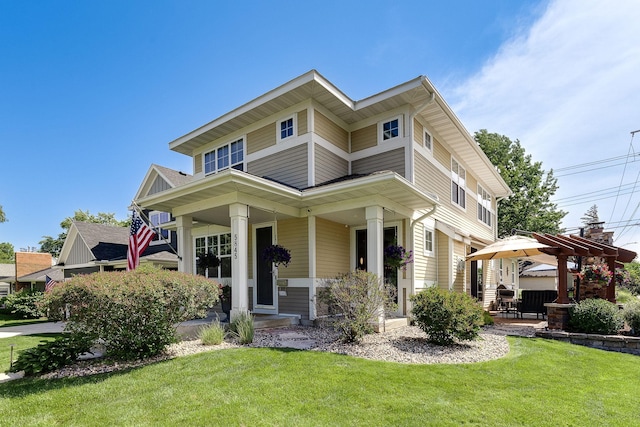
[{"left": 532, "top": 233, "right": 637, "bottom": 304}]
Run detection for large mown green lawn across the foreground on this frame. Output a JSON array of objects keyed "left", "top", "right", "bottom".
[{"left": 0, "top": 337, "right": 640, "bottom": 426}]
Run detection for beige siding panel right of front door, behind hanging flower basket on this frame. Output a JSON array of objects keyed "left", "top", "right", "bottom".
[{"left": 278, "top": 218, "right": 309, "bottom": 279}]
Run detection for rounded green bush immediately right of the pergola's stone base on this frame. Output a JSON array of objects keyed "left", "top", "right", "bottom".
[{"left": 569, "top": 298, "right": 624, "bottom": 335}]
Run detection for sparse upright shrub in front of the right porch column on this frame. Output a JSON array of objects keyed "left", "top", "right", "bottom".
[{"left": 318, "top": 270, "right": 396, "bottom": 342}]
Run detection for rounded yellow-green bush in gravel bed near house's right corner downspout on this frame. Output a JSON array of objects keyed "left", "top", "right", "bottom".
[{"left": 411, "top": 287, "right": 483, "bottom": 345}]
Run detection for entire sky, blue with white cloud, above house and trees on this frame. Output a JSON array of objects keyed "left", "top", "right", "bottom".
[{"left": 0, "top": 0, "right": 640, "bottom": 258}]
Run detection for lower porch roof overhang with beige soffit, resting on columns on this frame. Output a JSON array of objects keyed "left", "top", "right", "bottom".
[{"left": 137, "top": 169, "right": 437, "bottom": 226}]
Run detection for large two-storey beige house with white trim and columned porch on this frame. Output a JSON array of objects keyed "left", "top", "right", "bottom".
[{"left": 135, "top": 70, "right": 510, "bottom": 320}]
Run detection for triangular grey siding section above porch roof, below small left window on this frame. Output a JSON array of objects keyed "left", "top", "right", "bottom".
[{"left": 247, "top": 144, "right": 309, "bottom": 188}]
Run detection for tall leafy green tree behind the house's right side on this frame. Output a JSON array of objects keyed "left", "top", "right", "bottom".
[{"left": 475, "top": 129, "right": 567, "bottom": 237}]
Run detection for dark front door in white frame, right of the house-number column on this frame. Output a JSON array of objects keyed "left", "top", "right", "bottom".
[{"left": 253, "top": 226, "right": 277, "bottom": 313}]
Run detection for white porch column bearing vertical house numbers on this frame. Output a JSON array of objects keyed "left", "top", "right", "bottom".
[{"left": 229, "top": 203, "right": 249, "bottom": 319}]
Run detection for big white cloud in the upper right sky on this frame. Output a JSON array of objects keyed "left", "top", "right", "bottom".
[{"left": 448, "top": 0, "right": 640, "bottom": 251}]
